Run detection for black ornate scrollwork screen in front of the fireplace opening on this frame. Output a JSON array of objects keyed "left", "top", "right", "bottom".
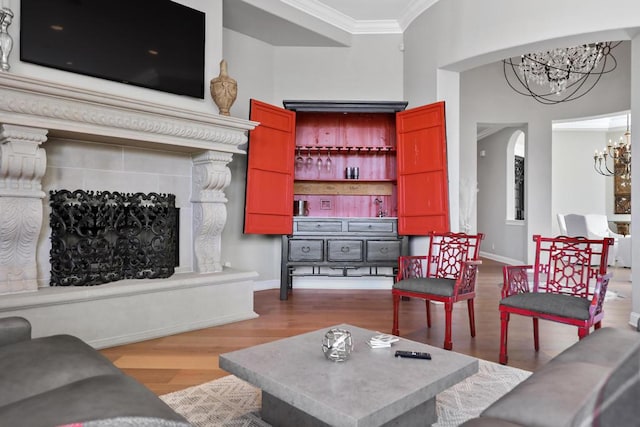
[{"left": 50, "top": 190, "right": 178, "bottom": 286}]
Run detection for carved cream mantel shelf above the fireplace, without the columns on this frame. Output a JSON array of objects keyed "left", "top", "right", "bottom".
[{"left": 0, "top": 73, "right": 257, "bottom": 153}]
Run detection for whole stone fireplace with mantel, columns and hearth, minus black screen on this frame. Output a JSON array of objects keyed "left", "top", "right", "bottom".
[{"left": 0, "top": 73, "right": 257, "bottom": 346}]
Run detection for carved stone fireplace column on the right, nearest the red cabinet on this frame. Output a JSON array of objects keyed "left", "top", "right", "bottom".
[{"left": 191, "top": 151, "right": 232, "bottom": 273}]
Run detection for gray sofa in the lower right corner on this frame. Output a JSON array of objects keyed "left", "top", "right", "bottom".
[{"left": 463, "top": 328, "right": 640, "bottom": 427}]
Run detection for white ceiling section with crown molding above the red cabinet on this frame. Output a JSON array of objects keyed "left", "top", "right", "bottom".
[{"left": 222, "top": 0, "right": 438, "bottom": 47}]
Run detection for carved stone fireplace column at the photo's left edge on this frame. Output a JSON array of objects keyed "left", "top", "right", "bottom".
[{"left": 0, "top": 124, "right": 48, "bottom": 294}]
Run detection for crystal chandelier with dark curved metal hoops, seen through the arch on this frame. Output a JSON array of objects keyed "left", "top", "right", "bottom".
[{"left": 502, "top": 42, "right": 621, "bottom": 105}]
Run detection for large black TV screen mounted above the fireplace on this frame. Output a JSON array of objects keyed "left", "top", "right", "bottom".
[{"left": 20, "top": 0, "right": 205, "bottom": 98}]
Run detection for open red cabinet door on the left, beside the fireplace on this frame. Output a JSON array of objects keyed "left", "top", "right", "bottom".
[{"left": 244, "top": 99, "right": 296, "bottom": 234}]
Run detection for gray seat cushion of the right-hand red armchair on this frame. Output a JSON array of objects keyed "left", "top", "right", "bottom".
[{"left": 500, "top": 292, "right": 591, "bottom": 320}]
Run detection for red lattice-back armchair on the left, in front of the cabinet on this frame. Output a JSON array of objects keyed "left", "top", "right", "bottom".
[{"left": 391, "top": 233, "right": 484, "bottom": 350}]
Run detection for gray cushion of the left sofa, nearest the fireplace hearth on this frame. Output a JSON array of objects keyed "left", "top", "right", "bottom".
[{"left": 0, "top": 335, "right": 122, "bottom": 406}]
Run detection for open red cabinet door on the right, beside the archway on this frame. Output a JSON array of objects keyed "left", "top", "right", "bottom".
[{"left": 396, "top": 101, "right": 450, "bottom": 236}]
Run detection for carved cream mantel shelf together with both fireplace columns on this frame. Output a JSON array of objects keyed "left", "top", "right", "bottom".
[{"left": 0, "top": 73, "right": 258, "bottom": 294}]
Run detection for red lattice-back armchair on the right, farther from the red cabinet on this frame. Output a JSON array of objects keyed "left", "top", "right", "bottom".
[{"left": 499, "top": 235, "right": 613, "bottom": 365}]
